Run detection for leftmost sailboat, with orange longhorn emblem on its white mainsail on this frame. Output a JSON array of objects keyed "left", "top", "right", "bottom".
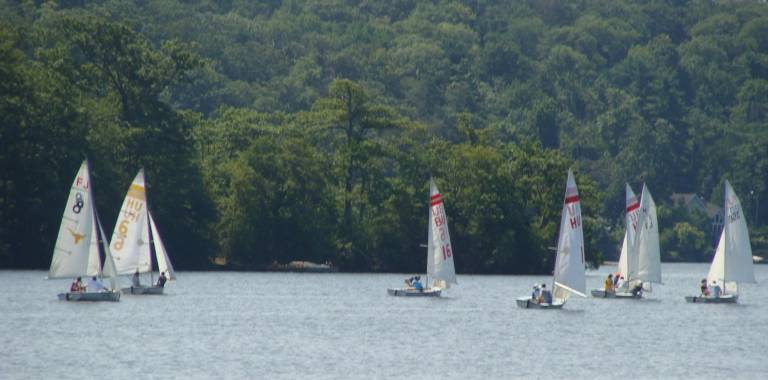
[{"left": 48, "top": 160, "right": 120, "bottom": 301}]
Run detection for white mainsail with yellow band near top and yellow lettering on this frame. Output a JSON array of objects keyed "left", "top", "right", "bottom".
[{"left": 109, "top": 169, "right": 152, "bottom": 275}]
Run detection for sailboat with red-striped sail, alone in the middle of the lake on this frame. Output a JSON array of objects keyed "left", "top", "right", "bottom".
[{"left": 387, "top": 178, "right": 458, "bottom": 297}]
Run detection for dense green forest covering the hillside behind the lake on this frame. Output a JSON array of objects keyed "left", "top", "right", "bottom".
[{"left": 0, "top": 0, "right": 768, "bottom": 273}]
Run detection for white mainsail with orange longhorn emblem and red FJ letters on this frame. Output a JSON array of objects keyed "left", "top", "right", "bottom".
[{"left": 48, "top": 160, "right": 99, "bottom": 278}]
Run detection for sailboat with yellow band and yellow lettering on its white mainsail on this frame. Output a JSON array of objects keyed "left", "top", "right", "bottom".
[{"left": 110, "top": 169, "right": 176, "bottom": 294}]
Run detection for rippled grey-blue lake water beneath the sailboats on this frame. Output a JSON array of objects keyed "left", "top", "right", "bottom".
[{"left": 0, "top": 264, "right": 768, "bottom": 379}]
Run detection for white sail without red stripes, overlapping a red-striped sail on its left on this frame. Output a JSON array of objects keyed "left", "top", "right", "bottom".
[{"left": 636, "top": 184, "right": 661, "bottom": 284}]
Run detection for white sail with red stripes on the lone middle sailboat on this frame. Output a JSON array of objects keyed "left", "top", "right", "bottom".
[{"left": 427, "top": 178, "right": 457, "bottom": 288}]
